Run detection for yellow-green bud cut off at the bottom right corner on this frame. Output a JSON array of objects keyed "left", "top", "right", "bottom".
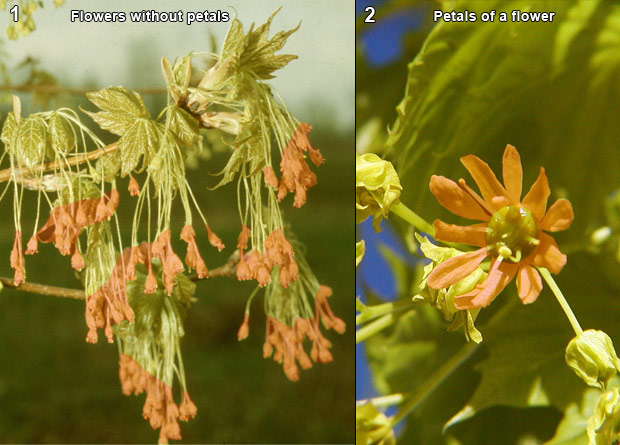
[{"left": 586, "top": 388, "right": 620, "bottom": 445}]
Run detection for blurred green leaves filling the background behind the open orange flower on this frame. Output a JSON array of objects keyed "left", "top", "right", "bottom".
[{"left": 357, "top": 0, "right": 620, "bottom": 444}]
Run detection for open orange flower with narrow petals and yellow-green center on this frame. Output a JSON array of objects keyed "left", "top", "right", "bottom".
[{"left": 427, "top": 145, "right": 573, "bottom": 309}]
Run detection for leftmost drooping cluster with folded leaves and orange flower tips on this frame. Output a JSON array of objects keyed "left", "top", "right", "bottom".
[{"left": 0, "top": 96, "right": 109, "bottom": 285}]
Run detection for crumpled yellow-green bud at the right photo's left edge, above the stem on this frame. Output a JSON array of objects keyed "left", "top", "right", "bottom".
[{"left": 355, "top": 153, "right": 402, "bottom": 232}]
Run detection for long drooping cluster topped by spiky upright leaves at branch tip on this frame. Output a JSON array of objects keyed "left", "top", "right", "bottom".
[{"left": 157, "top": 11, "right": 323, "bottom": 292}]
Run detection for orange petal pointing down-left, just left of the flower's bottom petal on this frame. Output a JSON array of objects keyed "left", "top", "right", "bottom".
[{"left": 454, "top": 260, "right": 519, "bottom": 309}]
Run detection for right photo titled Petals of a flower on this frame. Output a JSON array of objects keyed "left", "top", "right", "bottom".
[{"left": 355, "top": 0, "right": 620, "bottom": 445}]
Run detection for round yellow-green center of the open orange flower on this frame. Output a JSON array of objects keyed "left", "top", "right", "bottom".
[{"left": 486, "top": 206, "right": 540, "bottom": 263}]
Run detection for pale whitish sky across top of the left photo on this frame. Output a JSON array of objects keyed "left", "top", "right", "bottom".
[{"left": 0, "top": 0, "right": 355, "bottom": 128}]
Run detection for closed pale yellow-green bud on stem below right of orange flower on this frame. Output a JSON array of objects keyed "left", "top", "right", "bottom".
[{"left": 565, "top": 329, "right": 620, "bottom": 388}]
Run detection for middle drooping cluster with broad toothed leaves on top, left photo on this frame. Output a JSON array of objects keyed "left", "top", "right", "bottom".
[{"left": 83, "top": 85, "right": 224, "bottom": 293}]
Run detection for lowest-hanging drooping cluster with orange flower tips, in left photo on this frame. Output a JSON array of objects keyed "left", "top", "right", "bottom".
[{"left": 114, "top": 258, "right": 197, "bottom": 443}]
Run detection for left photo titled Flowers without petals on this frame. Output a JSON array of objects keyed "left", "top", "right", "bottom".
[{"left": 0, "top": 0, "right": 355, "bottom": 444}]
